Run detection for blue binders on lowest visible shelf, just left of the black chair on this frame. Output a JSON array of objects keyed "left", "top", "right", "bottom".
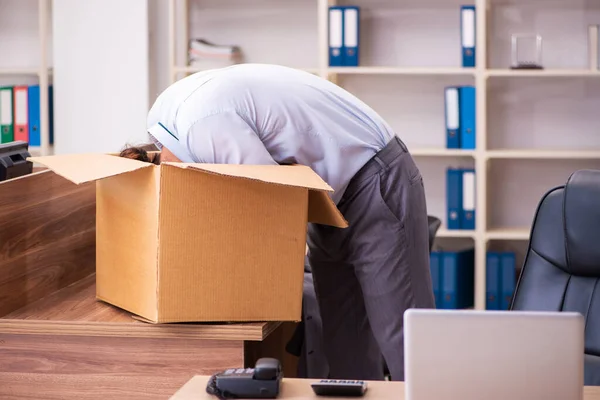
[{"left": 485, "top": 251, "right": 517, "bottom": 310}]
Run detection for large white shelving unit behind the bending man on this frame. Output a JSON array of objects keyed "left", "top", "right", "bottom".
[{"left": 169, "top": 0, "right": 600, "bottom": 309}]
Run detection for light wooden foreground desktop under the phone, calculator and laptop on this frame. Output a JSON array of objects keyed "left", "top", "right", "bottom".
[{"left": 171, "top": 376, "right": 600, "bottom": 400}]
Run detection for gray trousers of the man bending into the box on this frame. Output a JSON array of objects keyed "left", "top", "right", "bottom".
[{"left": 304, "top": 138, "right": 435, "bottom": 381}]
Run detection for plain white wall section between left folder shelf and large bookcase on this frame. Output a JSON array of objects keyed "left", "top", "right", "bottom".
[{"left": 53, "top": 0, "right": 149, "bottom": 154}]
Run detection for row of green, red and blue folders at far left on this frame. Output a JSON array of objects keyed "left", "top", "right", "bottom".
[{"left": 0, "top": 85, "right": 54, "bottom": 146}]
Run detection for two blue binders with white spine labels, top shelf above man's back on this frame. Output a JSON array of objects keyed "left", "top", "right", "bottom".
[{"left": 329, "top": 6, "right": 360, "bottom": 67}]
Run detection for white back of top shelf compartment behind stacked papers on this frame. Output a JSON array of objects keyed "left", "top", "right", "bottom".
[{"left": 183, "top": 0, "right": 319, "bottom": 71}]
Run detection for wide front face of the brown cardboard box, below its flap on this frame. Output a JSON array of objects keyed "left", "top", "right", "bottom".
[{"left": 159, "top": 164, "right": 308, "bottom": 322}]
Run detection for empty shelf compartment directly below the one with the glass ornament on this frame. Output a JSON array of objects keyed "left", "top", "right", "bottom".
[{"left": 486, "top": 75, "right": 600, "bottom": 151}]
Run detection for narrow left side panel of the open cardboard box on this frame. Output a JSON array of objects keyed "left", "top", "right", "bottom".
[{"left": 96, "top": 167, "right": 160, "bottom": 320}]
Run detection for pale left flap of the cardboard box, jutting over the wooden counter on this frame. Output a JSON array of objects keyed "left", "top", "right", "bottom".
[{"left": 28, "top": 153, "right": 155, "bottom": 185}]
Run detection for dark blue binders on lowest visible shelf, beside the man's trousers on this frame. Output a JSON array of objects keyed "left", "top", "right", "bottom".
[{"left": 430, "top": 248, "right": 475, "bottom": 309}]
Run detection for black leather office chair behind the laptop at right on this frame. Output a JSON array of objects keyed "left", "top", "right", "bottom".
[{"left": 510, "top": 170, "right": 600, "bottom": 386}]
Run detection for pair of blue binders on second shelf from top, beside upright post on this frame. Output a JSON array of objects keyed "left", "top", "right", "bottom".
[{"left": 444, "top": 86, "right": 476, "bottom": 150}]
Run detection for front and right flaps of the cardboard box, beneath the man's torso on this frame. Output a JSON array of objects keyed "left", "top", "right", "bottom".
[{"left": 163, "top": 163, "right": 348, "bottom": 228}]
